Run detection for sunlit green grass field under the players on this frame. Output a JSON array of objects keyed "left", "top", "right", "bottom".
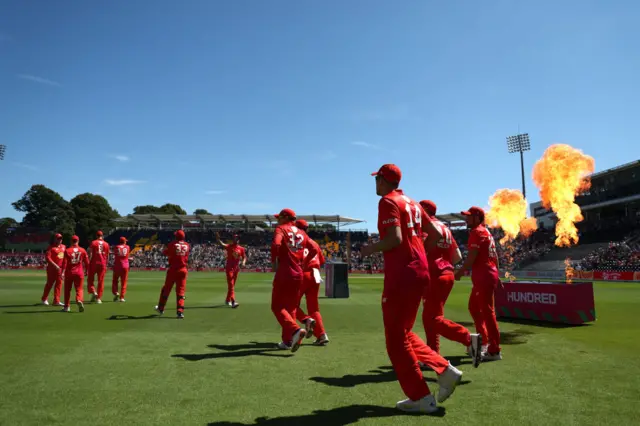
[{"left": 0, "top": 272, "right": 640, "bottom": 426}]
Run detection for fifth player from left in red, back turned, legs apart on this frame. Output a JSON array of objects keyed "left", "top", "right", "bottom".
[{"left": 155, "top": 230, "right": 191, "bottom": 319}]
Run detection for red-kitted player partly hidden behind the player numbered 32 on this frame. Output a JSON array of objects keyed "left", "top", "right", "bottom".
[{"left": 296, "top": 219, "right": 329, "bottom": 346}]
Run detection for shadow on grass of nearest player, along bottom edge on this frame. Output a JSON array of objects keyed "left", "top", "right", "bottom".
[{"left": 208, "top": 405, "right": 446, "bottom": 426}]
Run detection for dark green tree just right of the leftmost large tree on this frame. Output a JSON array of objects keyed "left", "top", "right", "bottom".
[{"left": 70, "top": 192, "right": 120, "bottom": 245}]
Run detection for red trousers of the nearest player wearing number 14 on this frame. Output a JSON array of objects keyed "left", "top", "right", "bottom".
[{"left": 382, "top": 280, "right": 449, "bottom": 401}]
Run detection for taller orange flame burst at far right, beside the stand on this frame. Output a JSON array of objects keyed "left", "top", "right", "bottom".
[{"left": 533, "top": 144, "right": 595, "bottom": 247}]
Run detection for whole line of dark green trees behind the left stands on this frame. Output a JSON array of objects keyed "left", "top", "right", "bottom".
[{"left": 0, "top": 185, "right": 210, "bottom": 245}]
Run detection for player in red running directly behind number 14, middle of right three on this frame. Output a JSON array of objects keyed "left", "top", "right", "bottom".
[{"left": 420, "top": 200, "right": 482, "bottom": 368}]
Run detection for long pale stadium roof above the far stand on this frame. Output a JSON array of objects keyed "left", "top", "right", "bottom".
[{"left": 114, "top": 214, "right": 365, "bottom": 228}]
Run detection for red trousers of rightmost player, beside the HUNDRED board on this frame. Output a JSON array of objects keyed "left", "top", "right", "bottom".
[{"left": 469, "top": 274, "right": 500, "bottom": 354}]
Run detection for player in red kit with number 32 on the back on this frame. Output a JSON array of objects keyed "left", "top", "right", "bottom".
[{"left": 271, "top": 209, "right": 318, "bottom": 352}]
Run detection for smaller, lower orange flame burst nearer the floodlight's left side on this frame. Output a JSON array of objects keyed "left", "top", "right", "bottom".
[{"left": 486, "top": 189, "right": 538, "bottom": 244}]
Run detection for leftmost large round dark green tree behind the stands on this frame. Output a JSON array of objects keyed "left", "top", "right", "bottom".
[{"left": 11, "top": 185, "right": 76, "bottom": 240}]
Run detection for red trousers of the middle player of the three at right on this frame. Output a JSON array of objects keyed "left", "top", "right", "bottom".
[{"left": 422, "top": 274, "right": 471, "bottom": 353}]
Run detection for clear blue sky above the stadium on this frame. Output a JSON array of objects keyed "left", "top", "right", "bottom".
[{"left": 0, "top": 0, "right": 640, "bottom": 230}]
